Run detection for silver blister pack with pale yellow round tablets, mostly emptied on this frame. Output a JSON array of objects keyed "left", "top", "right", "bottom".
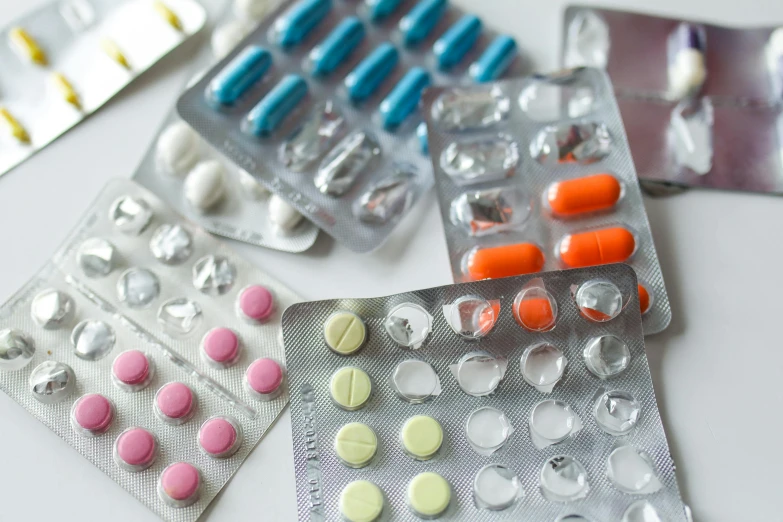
[{"left": 283, "top": 264, "right": 687, "bottom": 522}]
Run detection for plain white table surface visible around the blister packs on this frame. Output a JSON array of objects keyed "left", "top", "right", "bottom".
[{"left": 0, "top": 0, "right": 783, "bottom": 522}]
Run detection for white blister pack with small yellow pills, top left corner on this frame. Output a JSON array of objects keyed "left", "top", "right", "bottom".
[{"left": 0, "top": 0, "right": 206, "bottom": 174}]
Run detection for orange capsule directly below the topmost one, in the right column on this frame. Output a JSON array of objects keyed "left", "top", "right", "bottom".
[{"left": 557, "top": 227, "right": 636, "bottom": 268}]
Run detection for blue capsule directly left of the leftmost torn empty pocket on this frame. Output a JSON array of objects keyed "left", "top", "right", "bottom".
[{"left": 245, "top": 74, "right": 307, "bottom": 136}]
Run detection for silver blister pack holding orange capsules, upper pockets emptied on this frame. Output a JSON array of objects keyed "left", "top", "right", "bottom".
[{"left": 424, "top": 68, "right": 671, "bottom": 334}]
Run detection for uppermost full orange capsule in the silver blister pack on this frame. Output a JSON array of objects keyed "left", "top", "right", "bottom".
[{"left": 544, "top": 174, "right": 623, "bottom": 217}]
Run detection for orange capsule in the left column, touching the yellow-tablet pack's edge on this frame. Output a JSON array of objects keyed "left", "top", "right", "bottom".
[{"left": 465, "top": 243, "right": 544, "bottom": 281}]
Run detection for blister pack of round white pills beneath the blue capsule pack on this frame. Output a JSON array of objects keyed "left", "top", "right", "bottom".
[{"left": 134, "top": 0, "right": 318, "bottom": 252}]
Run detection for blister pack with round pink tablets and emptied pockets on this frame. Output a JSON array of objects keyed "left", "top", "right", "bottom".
[{"left": 0, "top": 180, "right": 299, "bottom": 522}]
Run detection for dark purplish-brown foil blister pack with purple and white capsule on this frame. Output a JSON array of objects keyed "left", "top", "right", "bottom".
[{"left": 562, "top": 6, "right": 783, "bottom": 194}]
